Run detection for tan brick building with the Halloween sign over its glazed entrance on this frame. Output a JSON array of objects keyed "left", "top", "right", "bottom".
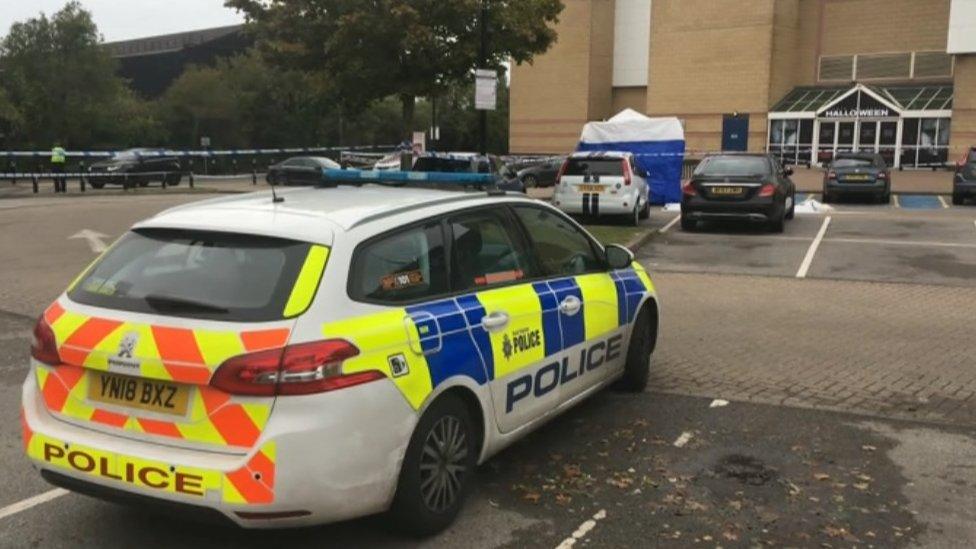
[{"left": 510, "top": 0, "right": 976, "bottom": 167}]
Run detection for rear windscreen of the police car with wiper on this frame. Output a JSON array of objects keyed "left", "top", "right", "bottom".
[{"left": 68, "top": 229, "right": 320, "bottom": 322}]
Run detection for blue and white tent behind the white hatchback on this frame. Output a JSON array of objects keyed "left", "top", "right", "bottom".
[{"left": 576, "top": 109, "right": 685, "bottom": 204}]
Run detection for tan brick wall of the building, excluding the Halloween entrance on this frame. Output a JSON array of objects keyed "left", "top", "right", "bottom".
[{"left": 511, "top": 0, "right": 960, "bottom": 156}]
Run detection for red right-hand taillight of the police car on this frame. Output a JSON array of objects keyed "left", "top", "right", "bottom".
[{"left": 210, "top": 339, "right": 385, "bottom": 396}]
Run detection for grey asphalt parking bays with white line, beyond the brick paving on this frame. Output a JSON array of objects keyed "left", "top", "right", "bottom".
[{"left": 640, "top": 193, "right": 976, "bottom": 285}]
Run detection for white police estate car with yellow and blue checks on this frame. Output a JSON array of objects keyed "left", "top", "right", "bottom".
[{"left": 22, "top": 173, "right": 658, "bottom": 535}]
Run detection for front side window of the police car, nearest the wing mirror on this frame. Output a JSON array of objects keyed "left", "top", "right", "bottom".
[{"left": 514, "top": 206, "right": 604, "bottom": 276}]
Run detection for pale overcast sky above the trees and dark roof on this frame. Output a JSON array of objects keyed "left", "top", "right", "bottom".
[{"left": 0, "top": 0, "right": 244, "bottom": 42}]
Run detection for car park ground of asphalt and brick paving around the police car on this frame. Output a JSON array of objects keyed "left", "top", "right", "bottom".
[{"left": 0, "top": 187, "right": 976, "bottom": 548}]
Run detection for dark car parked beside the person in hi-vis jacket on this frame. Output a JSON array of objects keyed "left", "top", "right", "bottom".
[{"left": 86, "top": 149, "right": 183, "bottom": 189}]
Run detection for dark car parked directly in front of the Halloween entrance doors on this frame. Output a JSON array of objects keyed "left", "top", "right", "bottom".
[{"left": 823, "top": 152, "right": 891, "bottom": 204}]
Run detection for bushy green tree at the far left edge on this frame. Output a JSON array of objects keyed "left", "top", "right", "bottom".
[{"left": 0, "top": 1, "right": 162, "bottom": 147}]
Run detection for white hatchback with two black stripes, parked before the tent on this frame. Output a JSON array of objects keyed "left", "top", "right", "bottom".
[{"left": 552, "top": 151, "right": 651, "bottom": 226}]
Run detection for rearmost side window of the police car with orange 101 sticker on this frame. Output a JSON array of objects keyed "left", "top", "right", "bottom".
[{"left": 350, "top": 223, "right": 448, "bottom": 303}]
